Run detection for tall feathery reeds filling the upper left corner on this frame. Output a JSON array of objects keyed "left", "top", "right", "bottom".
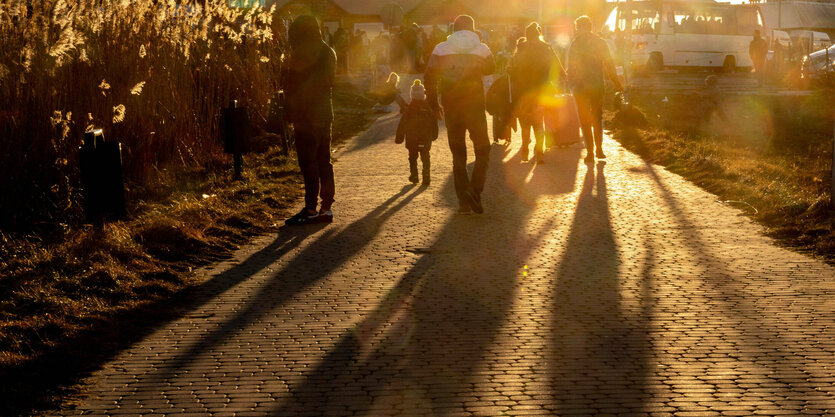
[{"left": 0, "top": 0, "right": 285, "bottom": 231}]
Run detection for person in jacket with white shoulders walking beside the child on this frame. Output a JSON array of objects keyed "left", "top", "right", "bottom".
[{"left": 425, "top": 15, "right": 494, "bottom": 214}]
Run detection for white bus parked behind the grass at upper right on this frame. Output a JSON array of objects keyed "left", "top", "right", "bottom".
[{"left": 602, "top": 0, "right": 765, "bottom": 72}]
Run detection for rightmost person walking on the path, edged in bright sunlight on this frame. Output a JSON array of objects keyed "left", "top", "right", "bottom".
[{"left": 567, "top": 16, "right": 623, "bottom": 163}]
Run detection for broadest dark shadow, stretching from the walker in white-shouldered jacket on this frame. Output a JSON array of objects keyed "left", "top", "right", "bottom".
[{"left": 264, "top": 148, "right": 576, "bottom": 416}]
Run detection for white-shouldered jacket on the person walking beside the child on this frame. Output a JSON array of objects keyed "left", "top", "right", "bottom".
[{"left": 424, "top": 30, "right": 495, "bottom": 112}]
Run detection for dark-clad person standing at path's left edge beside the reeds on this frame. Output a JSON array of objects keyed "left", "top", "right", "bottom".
[{"left": 284, "top": 15, "right": 337, "bottom": 225}]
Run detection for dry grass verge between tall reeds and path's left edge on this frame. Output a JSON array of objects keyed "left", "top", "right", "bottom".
[{"left": 0, "top": 80, "right": 370, "bottom": 415}]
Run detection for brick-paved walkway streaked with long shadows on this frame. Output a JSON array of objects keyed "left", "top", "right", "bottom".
[{"left": 66, "top": 103, "right": 835, "bottom": 416}]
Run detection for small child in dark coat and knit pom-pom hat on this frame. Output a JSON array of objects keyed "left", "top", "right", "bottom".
[{"left": 394, "top": 80, "right": 438, "bottom": 186}]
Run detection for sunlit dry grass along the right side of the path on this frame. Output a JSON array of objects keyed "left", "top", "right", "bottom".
[{"left": 610, "top": 90, "right": 835, "bottom": 262}]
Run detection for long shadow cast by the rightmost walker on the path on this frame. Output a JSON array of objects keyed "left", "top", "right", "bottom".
[{"left": 550, "top": 163, "right": 651, "bottom": 415}]
